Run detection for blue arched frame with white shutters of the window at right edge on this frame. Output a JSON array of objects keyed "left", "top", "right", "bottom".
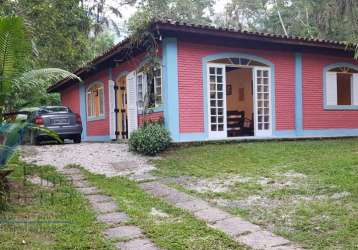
[{"left": 323, "top": 63, "right": 358, "bottom": 110}]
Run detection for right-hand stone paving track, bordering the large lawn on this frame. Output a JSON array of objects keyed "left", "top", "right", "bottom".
[{"left": 139, "top": 181, "right": 301, "bottom": 250}]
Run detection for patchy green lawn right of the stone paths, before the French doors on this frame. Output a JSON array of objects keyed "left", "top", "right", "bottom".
[{"left": 155, "top": 139, "right": 358, "bottom": 249}]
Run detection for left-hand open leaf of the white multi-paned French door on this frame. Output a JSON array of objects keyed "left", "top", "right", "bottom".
[{"left": 207, "top": 63, "right": 227, "bottom": 139}]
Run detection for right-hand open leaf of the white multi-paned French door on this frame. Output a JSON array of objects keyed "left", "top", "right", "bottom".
[{"left": 253, "top": 67, "right": 272, "bottom": 137}]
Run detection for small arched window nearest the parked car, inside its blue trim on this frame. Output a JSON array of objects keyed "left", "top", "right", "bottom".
[{"left": 87, "top": 83, "right": 104, "bottom": 118}]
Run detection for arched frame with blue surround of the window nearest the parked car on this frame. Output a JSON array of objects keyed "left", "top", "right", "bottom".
[{"left": 86, "top": 82, "right": 105, "bottom": 121}]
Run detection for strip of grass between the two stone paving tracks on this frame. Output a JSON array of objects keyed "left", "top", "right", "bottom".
[{"left": 86, "top": 172, "right": 244, "bottom": 250}]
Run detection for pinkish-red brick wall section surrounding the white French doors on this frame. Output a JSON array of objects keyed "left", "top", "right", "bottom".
[{"left": 178, "top": 41, "right": 295, "bottom": 133}]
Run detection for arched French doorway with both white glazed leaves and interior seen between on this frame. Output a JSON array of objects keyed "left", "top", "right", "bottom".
[{"left": 207, "top": 58, "right": 272, "bottom": 139}]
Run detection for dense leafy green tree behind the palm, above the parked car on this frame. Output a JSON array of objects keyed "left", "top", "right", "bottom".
[{"left": 0, "top": 0, "right": 114, "bottom": 108}]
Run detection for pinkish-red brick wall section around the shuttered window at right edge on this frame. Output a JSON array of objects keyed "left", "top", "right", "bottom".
[{"left": 302, "top": 54, "right": 358, "bottom": 129}]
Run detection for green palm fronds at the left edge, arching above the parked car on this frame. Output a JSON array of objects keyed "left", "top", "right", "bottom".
[{"left": 0, "top": 16, "right": 79, "bottom": 119}]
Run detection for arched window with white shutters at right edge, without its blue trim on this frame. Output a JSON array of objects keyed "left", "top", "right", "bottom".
[{"left": 326, "top": 67, "right": 358, "bottom": 106}]
